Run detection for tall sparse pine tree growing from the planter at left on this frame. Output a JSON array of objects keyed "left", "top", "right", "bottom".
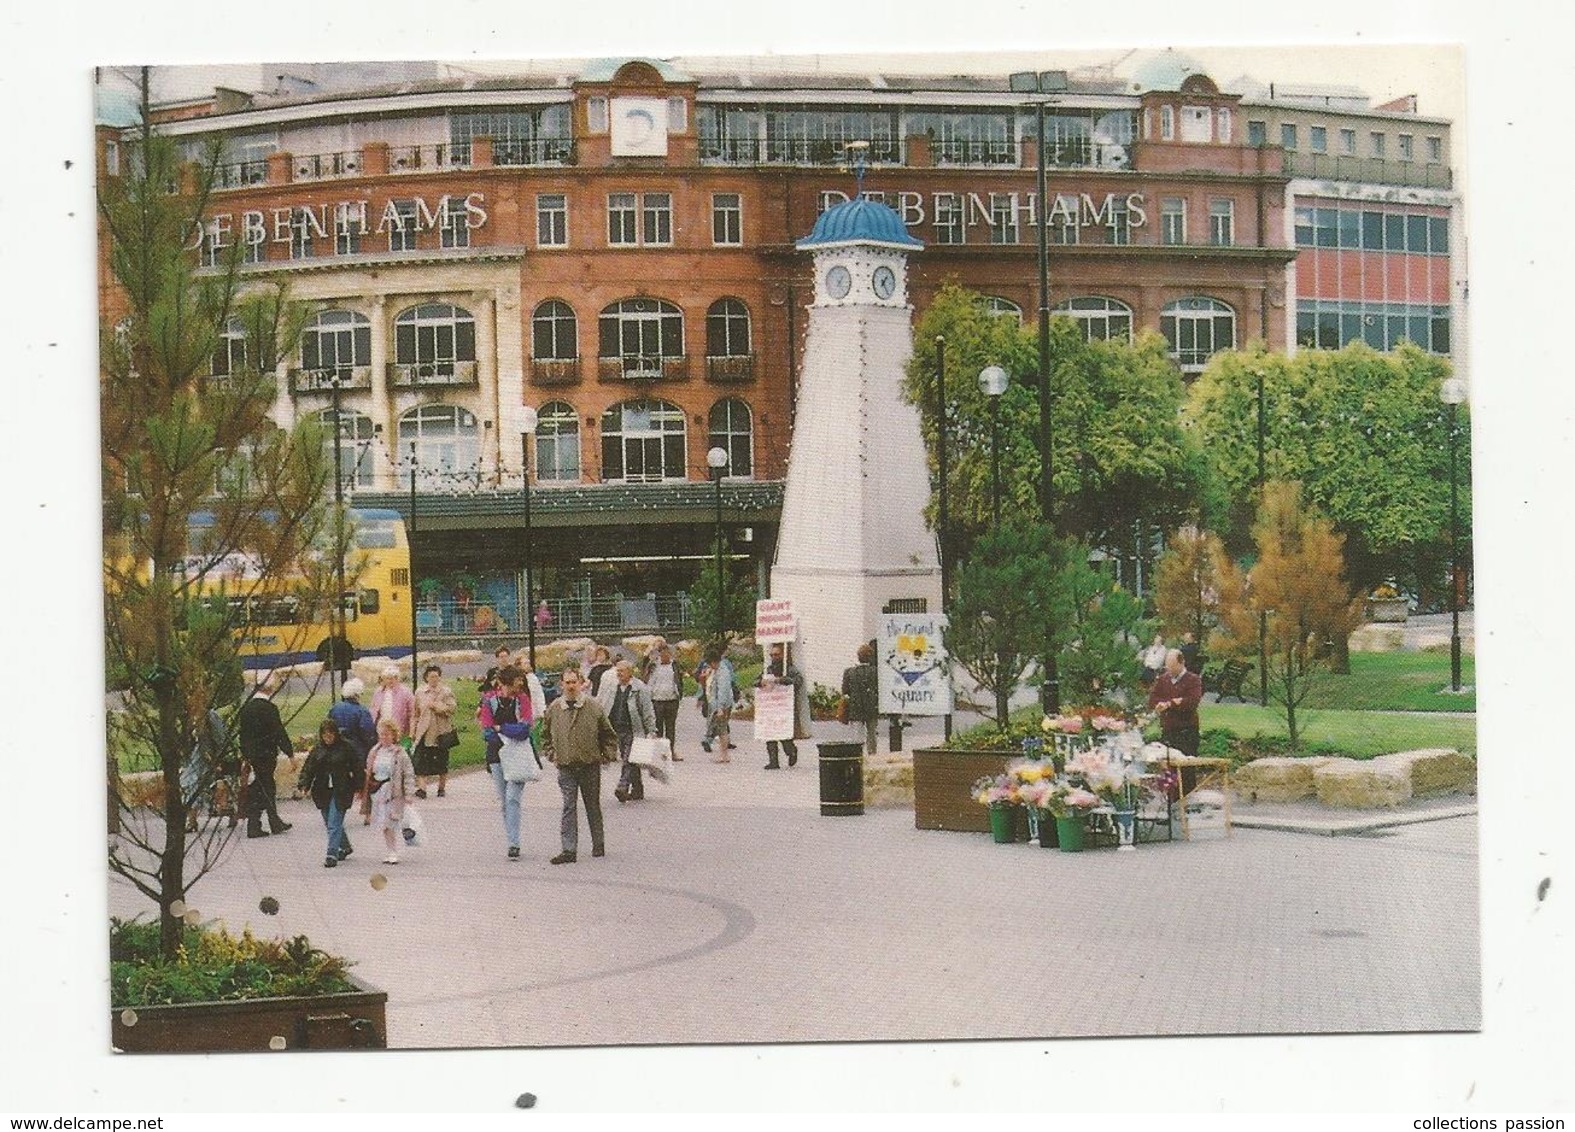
[{"left": 99, "top": 76, "right": 343, "bottom": 956}]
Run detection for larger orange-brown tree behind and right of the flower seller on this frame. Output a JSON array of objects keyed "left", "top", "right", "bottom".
[{"left": 1222, "top": 480, "right": 1362, "bottom": 751}]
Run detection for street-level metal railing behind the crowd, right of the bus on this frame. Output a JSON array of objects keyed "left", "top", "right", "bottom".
[{"left": 416, "top": 594, "right": 691, "bottom": 642}]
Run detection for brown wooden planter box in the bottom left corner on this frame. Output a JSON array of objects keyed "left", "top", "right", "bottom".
[{"left": 110, "top": 976, "right": 389, "bottom": 1053}]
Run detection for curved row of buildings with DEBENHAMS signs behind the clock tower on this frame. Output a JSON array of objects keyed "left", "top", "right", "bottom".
[{"left": 99, "top": 60, "right": 1463, "bottom": 627}]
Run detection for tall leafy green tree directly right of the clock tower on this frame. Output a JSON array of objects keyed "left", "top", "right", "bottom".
[{"left": 906, "top": 285, "right": 1213, "bottom": 569}]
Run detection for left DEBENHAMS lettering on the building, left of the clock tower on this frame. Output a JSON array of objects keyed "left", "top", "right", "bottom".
[{"left": 189, "top": 192, "right": 487, "bottom": 249}]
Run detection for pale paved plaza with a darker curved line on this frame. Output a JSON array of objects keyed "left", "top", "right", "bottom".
[{"left": 110, "top": 705, "right": 1482, "bottom": 1049}]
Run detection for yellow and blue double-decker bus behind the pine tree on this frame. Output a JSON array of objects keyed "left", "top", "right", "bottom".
[{"left": 191, "top": 509, "right": 411, "bottom": 668}]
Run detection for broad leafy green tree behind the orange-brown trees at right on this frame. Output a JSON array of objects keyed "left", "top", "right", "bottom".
[{"left": 1188, "top": 342, "right": 1469, "bottom": 592}]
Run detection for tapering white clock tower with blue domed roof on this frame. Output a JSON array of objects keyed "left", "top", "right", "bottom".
[{"left": 772, "top": 197, "right": 940, "bottom": 688}]
